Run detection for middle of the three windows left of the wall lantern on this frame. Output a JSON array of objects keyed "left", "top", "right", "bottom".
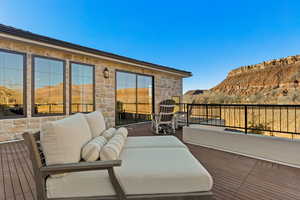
[{"left": 32, "top": 56, "right": 65, "bottom": 116}]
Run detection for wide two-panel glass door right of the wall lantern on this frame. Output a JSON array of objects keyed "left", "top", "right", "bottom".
[{"left": 116, "top": 71, "right": 154, "bottom": 125}]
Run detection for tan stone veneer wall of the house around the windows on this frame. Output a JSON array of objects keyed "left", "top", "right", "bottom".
[{"left": 0, "top": 38, "right": 182, "bottom": 141}]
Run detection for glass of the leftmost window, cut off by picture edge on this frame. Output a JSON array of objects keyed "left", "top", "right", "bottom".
[{"left": 0, "top": 50, "right": 26, "bottom": 119}]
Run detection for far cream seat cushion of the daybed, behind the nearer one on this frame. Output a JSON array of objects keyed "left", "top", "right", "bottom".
[{"left": 125, "top": 136, "right": 187, "bottom": 148}]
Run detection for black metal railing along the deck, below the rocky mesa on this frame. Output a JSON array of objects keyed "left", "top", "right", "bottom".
[{"left": 184, "top": 104, "right": 300, "bottom": 138}]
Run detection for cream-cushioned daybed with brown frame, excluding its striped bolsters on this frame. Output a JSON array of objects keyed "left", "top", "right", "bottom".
[{"left": 23, "top": 112, "right": 213, "bottom": 199}]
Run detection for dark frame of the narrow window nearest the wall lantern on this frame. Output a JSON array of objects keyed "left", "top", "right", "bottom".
[{"left": 69, "top": 61, "right": 96, "bottom": 114}]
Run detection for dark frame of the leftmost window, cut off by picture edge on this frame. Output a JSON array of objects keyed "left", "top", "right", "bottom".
[{"left": 0, "top": 48, "right": 27, "bottom": 120}]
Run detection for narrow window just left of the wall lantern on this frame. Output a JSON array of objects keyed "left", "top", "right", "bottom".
[{"left": 70, "top": 63, "right": 95, "bottom": 113}]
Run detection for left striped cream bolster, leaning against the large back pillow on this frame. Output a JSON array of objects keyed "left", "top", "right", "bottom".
[{"left": 81, "top": 136, "right": 107, "bottom": 162}]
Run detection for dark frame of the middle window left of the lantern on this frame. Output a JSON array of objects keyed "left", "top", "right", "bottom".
[{"left": 31, "top": 54, "right": 66, "bottom": 117}]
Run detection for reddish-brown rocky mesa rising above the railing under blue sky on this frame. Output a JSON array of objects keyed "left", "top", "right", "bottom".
[{"left": 184, "top": 55, "right": 300, "bottom": 104}]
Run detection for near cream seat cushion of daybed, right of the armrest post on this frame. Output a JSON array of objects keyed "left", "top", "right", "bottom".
[{"left": 116, "top": 148, "right": 213, "bottom": 194}]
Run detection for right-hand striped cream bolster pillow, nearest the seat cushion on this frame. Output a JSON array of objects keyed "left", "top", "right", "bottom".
[{"left": 100, "top": 134, "right": 125, "bottom": 160}]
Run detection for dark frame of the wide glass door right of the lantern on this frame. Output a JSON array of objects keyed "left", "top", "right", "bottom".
[{"left": 115, "top": 69, "right": 155, "bottom": 126}]
